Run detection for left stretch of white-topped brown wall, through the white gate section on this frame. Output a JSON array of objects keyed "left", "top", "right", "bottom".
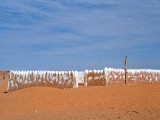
[{"left": 7, "top": 71, "right": 84, "bottom": 91}]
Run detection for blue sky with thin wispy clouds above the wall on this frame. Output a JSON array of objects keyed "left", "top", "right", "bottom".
[{"left": 0, "top": 0, "right": 160, "bottom": 70}]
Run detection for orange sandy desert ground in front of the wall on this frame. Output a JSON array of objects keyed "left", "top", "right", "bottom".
[{"left": 0, "top": 83, "right": 160, "bottom": 120}]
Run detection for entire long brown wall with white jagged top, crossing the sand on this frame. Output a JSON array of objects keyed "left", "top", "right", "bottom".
[{"left": 7, "top": 68, "right": 160, "bottom": 91}]
